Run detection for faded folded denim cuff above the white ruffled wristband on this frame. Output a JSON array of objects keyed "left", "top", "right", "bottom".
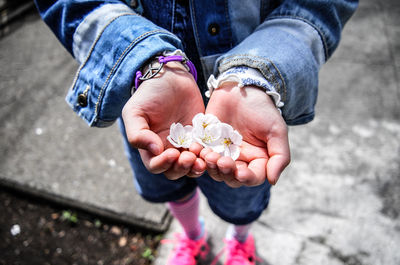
[{"left": 216, "top": 18, "right": 325, "bottom": 125}]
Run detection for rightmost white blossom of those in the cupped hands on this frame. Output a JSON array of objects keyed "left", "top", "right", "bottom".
[{"left": 211, "top": 123, "right": 243, "bottom": 160}]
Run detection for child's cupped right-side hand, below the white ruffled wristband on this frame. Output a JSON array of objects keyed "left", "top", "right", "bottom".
[{"left": 200, "top": 82, "right": 290, "bottom": 187}]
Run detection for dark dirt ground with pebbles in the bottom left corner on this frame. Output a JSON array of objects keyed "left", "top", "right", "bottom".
[{"left": 0, "top": 188, "right": 161, "bottom": 265}]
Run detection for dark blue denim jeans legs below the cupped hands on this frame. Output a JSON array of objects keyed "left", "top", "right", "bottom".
[{"left": 119, "top": 119, "right": 271, "bottom": 225}]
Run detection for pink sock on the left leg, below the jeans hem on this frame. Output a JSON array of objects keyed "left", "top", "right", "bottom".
[{"left": 168, "top": 190, "right": 202, "bottom": 240}]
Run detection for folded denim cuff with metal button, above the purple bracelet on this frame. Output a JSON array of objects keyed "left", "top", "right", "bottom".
[{"left": 66, "top": 11, "right": 182, "bottom": 127}]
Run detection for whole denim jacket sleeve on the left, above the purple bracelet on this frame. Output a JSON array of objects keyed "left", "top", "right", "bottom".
[{"left": 35, "top": 0, "right": 182, "bottom": 127}]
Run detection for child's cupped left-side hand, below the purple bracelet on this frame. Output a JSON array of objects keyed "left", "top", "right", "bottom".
[{"left": 122, "top": 62, "right": 205, "bottom": 179}]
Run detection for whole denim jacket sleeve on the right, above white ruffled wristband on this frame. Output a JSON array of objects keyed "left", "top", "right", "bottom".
[{"left": 215, "top": 0, "right": 358, "bottom": 125}]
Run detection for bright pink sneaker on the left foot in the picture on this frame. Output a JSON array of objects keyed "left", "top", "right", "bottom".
[{"left": 162, "top": 233, "right": 210, "bottom": 265}]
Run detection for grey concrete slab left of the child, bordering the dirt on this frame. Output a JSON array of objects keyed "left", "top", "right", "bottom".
[{"left": 0, "top": 8, "right": 171, "bottom": 231}]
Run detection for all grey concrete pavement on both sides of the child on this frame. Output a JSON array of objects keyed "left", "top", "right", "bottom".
[{"left": 0, "top": 0, "right": 400, "bottom": 265}]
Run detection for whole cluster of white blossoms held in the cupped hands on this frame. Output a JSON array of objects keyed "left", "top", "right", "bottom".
[{"left": 167, "top": 113, "right": 242, "bottom": 160}]
